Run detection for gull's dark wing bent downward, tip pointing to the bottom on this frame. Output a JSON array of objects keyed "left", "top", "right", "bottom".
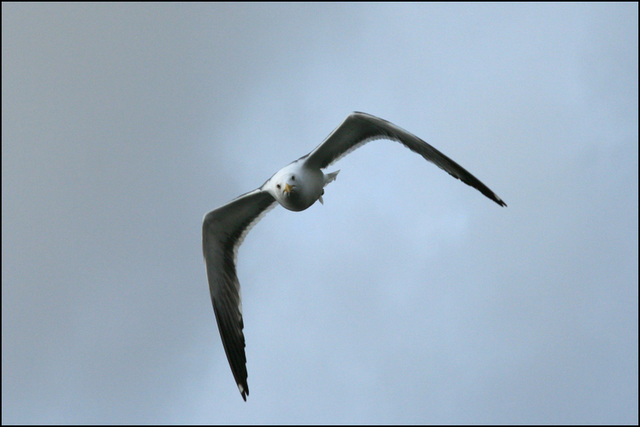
[{"left": 202, "top": 189, "right": 276, "bottom": 400}]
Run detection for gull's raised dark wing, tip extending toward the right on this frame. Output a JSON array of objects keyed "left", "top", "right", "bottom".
[{"left": 303, "top": 112, "right": 507, "bottom": 206}]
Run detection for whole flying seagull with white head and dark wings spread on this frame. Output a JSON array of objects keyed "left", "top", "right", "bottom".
[{"left": 202, "top": 112, "right": 506, "bottom": 401}]
